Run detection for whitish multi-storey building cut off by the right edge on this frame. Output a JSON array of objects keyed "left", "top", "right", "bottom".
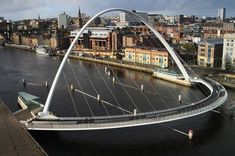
[{"left": 222, "top": 34, "right": 235, "bottom": 70}]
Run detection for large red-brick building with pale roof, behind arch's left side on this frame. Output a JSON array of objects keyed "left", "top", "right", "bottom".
[{"left": 70, "top": 27, "right": 117, "bottom": 56}]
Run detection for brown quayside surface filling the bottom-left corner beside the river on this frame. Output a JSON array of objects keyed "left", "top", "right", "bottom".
[{"left": 0, "top": 99, "right": 47, "bottom": 156}]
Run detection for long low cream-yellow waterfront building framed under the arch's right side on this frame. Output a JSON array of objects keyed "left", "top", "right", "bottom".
[{"left": 123, "top": 46, "right": 169, "bottom": 68}]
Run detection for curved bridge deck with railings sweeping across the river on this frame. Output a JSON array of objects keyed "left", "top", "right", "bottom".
[{"left": 22, "top": 79, "right": 227, "bottom": 131}]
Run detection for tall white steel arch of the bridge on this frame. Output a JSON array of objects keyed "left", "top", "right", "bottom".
[{"left": 39, "top": 8, "right": 190, "bottom": 118}]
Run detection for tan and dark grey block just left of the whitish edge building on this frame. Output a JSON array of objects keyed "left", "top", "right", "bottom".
[{"left": 197, "top": 38, "right": 223, "bottom": 68}]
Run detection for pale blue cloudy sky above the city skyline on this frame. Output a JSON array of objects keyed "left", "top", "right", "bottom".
[{"left": 0, "top": 0, "right": 235, "bottom": 20}]
